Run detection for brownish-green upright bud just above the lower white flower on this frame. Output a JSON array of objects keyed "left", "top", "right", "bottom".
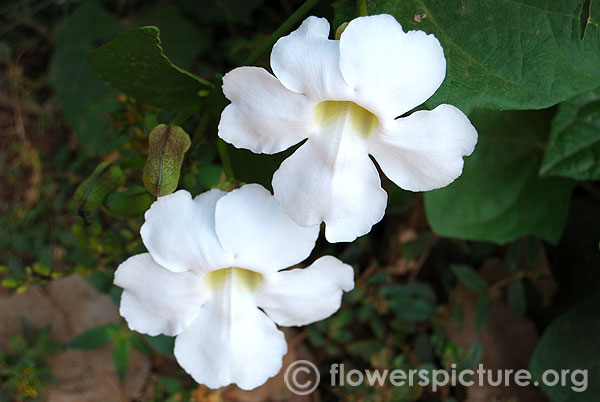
[{"left": 144, "top": 124, "right": 191, "bottom": 197}]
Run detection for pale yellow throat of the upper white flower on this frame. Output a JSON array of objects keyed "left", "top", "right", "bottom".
[{"left": 315, "top": 101, "right": 379, "bottom": 137}]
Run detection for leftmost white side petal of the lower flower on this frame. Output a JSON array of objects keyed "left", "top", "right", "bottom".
[{"left": 115, "top": 253, "right": 206, "bottom": 336}]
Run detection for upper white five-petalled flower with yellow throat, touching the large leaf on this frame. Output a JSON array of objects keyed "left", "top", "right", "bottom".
[{"left": 219, "top": 15, "right": 477, "bottom": 242}]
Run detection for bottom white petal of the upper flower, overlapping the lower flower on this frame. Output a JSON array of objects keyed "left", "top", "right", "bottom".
[{"left": 273, "top": 122, "right": 387, "bottom": 243}]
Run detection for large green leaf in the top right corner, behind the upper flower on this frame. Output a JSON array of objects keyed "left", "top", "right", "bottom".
[{"left": 335, "top": 0, "right": 600, "bottom": 112}]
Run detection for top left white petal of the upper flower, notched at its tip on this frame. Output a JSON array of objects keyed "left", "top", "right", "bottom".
[{"left": 271, "top": 17, "right": 354, "bottom": 102}]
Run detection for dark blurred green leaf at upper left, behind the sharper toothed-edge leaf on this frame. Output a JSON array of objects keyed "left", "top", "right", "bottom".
[{"left": 49, "top": 1, "right": 123, "bottom": 154}]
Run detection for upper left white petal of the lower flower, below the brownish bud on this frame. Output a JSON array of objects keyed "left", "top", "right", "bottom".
[{"left": 140, "top": 189, "right": 233, "bottom": 272}]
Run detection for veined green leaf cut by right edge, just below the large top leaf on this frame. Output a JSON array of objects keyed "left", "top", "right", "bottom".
[{"left": 540, "top": 91, "right": 600, "bottom": 180}]
